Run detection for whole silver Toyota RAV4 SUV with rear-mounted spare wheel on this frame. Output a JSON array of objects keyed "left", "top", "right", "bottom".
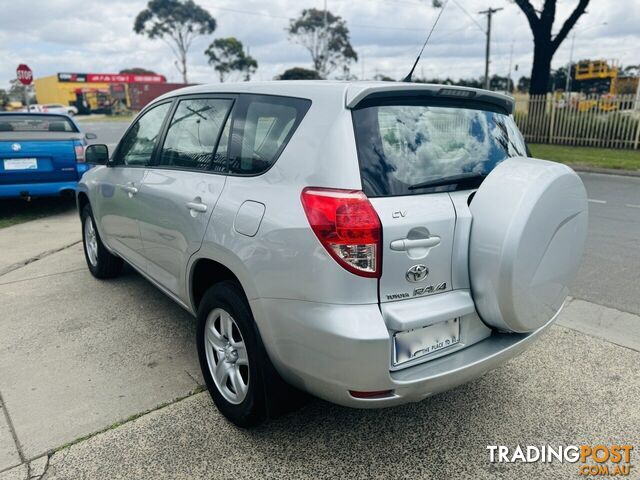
[{"left": 77, "top": 81, "right": 587, "bottom": 426}]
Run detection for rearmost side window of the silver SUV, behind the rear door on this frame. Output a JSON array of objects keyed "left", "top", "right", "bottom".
[{"left": 229, "top": 95, "right": 311, "bottom": 175}]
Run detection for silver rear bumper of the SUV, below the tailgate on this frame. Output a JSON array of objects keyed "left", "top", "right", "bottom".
[{"left": 251, "top": 299, "right": 555, "bottom": 408}]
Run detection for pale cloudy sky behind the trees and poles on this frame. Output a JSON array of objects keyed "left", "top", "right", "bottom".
[{"left": 0, "top": 0, "right": 640, "bottom": 88}]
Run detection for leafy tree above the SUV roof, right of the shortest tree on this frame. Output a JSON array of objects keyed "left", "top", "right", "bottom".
[{"left": 287, "top": 8, "right": 358, "bottom": 78}]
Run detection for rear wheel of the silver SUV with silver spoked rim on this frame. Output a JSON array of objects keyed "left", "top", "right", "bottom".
[{"left": 196, "top": 281, "right": 296, "bottom": 428}]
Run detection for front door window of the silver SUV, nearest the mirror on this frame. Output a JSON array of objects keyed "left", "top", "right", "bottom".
[{"left": 116, "top": 102, "right": 171, "bottom": 166}]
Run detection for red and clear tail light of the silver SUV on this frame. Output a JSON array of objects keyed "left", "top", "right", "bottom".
[{"left": 301, "top": 187, "right": 382, "bottom": 278}]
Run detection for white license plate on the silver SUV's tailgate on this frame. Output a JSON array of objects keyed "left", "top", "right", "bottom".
[{"left": 393, "top": 318, "right": 460, "bottom": 365}]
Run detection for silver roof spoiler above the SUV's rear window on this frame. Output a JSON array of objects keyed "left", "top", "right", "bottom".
[{"left": 345, "top": 82, "right": 514, "bottom": 114}]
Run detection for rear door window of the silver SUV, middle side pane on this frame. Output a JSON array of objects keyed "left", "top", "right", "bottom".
[{"left": 159, "top": 98, "right": 233, "bottom": 171}]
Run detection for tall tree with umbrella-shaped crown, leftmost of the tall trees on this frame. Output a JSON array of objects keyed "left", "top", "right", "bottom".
[{"left": 133, "top": 0, "right": 216, "bottom": 83}]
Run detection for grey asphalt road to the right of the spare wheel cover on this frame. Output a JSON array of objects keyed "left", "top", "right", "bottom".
[{"left": 571, "top": 173, "right": 640, "bottom": 315}]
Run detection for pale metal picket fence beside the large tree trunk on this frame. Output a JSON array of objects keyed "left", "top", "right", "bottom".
[{"left": 514, "top": 94, "right": 640, "bottom": 150}]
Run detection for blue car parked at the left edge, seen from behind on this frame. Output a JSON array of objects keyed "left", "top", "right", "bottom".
[{"left": 0, "top": 112, "right": 96, "bottom": 199}]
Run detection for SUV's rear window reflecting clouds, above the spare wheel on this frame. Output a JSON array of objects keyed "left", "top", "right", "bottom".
[{"left": 353, "top": 103, "right": 527, "bottom": 197}]
